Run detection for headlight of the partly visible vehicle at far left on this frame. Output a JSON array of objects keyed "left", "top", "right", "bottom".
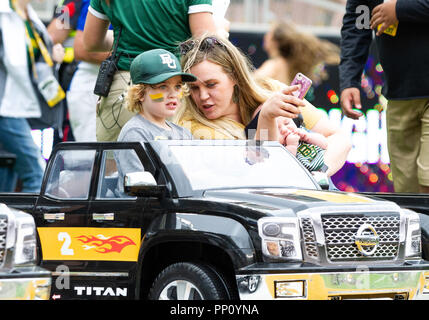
[{"left": 13, "top": 213, "right": 36, "bottom": 265}]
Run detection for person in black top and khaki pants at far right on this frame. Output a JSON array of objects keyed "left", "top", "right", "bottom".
[{"left": 339, "top": 0, "right": 429, "bottom": 193}]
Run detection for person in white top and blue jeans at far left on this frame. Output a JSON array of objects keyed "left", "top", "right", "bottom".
[{"left": 0, "top": 0, "right": 59, "bottom": 192}]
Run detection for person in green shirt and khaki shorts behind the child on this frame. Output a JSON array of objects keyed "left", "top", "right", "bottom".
[{"left": 83, "top": 0, "right": 216, "bottom": 141}]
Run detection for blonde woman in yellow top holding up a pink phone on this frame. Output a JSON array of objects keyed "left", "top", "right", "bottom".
[{"left": 175, "top": 35, "right": 350, "bottom": 175}]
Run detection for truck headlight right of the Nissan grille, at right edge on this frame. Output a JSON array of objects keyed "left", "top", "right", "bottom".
[{"left": 402, "top": 209, "right": 422, "bottom": 258}]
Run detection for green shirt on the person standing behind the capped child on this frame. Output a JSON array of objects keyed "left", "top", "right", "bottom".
[{"left": 89, "top": 0, "right": 212, "bottom": 70}]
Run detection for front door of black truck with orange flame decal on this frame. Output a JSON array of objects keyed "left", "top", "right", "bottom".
[{"left": 81, "top": 143, "right": 155, "bottom": 299}]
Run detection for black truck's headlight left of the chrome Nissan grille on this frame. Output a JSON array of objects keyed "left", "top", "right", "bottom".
[{"left": 258, "top": 217, "right": 302, "bottom": 260}]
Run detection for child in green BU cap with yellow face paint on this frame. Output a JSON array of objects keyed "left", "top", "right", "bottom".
[{"left": 115, "top": 49, "right": 197, "bottom": 190}]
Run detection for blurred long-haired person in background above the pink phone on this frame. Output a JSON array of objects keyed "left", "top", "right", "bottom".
[{"left": 255, "top": 22, "right": 340, "bottom": 84}]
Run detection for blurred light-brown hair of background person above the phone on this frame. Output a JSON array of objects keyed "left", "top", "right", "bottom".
[{"left": 272, "top": 21, "right": 340, "bottom": 83}]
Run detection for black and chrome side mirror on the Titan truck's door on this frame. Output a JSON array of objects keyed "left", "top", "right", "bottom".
[{"left": 124, "top": 171, "right": 167, "bottom": 197}]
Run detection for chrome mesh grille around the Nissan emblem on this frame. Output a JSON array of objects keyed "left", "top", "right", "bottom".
[{"left": 321, "top": 213, "right": 400, "bottom": 262}]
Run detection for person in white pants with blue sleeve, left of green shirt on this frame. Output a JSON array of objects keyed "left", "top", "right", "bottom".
[{"left": 67, "top": 0, "right": 110, "bottom": 141}]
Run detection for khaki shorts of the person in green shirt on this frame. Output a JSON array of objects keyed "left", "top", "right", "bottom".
[{"left": 96, "top": 71, "right": 135, "bottom": 141}]
